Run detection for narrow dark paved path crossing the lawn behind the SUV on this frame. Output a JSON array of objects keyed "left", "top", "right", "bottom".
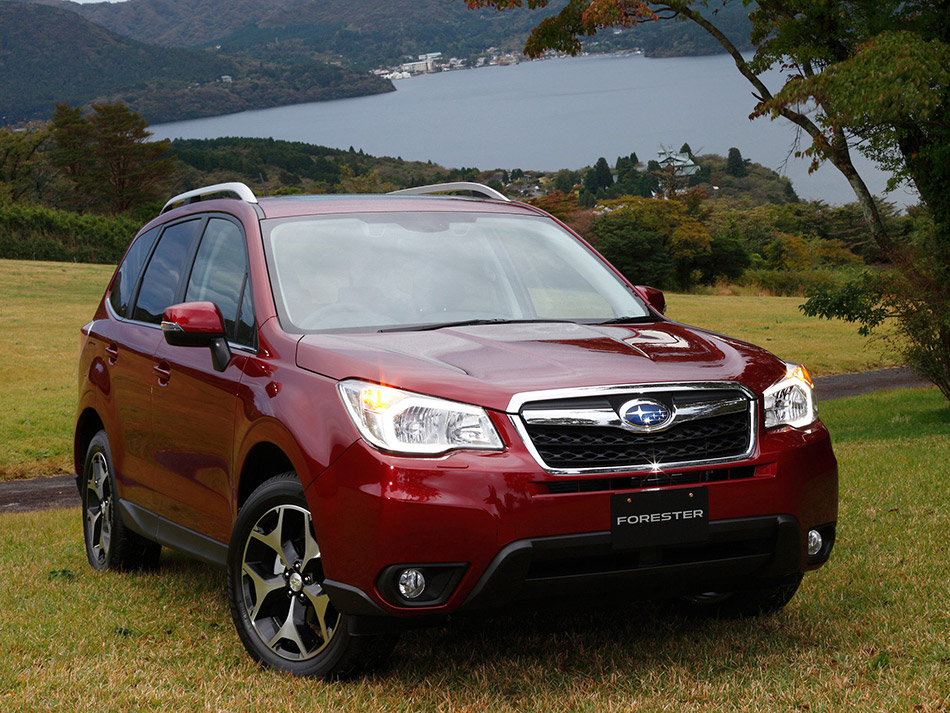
[{"left": 0, "top": 367, "right": 929, "bottom": 513}]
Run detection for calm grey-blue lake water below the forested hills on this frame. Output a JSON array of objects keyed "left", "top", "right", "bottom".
[{"left": 151, "top": 54, "right": 916, "bottom": 206}]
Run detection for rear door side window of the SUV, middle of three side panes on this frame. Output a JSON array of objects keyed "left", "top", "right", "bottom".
[{"left": 132, "top": 220, "right": 201, "bottom": 324}]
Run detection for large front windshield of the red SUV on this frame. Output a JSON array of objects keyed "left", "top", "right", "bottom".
[{"left": 264, "top": 212, "right": 649, "bottom": 332}]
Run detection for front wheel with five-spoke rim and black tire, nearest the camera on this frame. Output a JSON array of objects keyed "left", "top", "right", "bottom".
[{"left": 227, "top": 471, "right": 397, "bottom": 678}]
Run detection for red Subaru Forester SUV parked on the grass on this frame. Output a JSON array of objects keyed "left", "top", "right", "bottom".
[{"left": 75, "top": 184, "right": 838, "bottom": 676}]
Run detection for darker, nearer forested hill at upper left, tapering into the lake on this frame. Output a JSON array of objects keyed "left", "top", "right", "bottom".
[{"left": 0, "top": 2, "right": 393, "bottom": 125}]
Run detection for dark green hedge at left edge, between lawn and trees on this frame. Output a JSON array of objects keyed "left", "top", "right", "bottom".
[{"left": 0, "top": 204, "right": 141, "bottom": 264}]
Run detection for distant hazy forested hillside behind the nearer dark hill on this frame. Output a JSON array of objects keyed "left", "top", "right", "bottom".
[{"left": 33, "top": 0, "right": 750, "bottom": 67}]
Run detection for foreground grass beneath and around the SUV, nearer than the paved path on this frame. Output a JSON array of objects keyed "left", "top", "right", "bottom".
[{"left": 0, "top": 389, "right": 950, "bottom": 713}]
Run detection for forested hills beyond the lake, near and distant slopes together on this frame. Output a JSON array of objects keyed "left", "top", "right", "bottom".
[{"left": 0, "top": 0, "right": 749, "bottom": 124}]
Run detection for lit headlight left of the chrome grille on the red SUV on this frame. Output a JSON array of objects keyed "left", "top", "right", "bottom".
[{"left": 337, "top": 381, "right": 503, "bottom": 456}]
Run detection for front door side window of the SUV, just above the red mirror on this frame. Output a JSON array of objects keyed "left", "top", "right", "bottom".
[{"left": 185, "top": 218, "right": 254, "bottom": 344}]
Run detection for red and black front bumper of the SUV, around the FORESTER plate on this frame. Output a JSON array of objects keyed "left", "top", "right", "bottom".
[{"left": 307, "top": 423, "right": 838, "bottom": 618}]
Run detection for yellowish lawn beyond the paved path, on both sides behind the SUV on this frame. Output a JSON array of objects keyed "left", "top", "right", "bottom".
[{"left": 0, "top": 260, "right": 908, "bottom": 480}]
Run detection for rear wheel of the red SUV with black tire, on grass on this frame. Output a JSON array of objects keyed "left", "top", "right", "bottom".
[{"left": 81, "top": 431, "right": 162, "bottom": 570}]
